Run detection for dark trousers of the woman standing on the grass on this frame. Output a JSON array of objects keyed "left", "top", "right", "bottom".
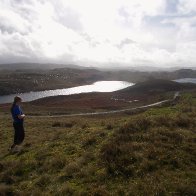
[{"left": 13, "top": 122, "right": 25, "bottom": 145}]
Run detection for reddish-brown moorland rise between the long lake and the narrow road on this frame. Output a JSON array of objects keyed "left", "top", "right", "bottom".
[{"left": 22, "top": 80, "right": 196, "bottom": 114}]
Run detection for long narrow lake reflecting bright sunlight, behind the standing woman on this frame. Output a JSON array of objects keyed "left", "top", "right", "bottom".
[{"left": 0, "top": 81, "right": 134, "bottom": 104}]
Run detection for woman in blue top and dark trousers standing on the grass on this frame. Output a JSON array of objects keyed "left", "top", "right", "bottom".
[{"left": 11, "top": 96, "right": 25, "bottom": 150}]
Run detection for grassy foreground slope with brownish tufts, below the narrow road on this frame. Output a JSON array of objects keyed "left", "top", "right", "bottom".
[{"left": 0, "top": 93, "right": 196, "bottom": 196}]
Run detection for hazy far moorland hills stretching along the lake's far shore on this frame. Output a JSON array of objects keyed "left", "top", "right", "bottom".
[{"left": 0, "top": 66, "right": 196, "bottom": 95}]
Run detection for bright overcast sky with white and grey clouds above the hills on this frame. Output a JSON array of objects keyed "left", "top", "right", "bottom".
[{"left": 0, "top": 0, "right": 196, "bottom": 67}]
